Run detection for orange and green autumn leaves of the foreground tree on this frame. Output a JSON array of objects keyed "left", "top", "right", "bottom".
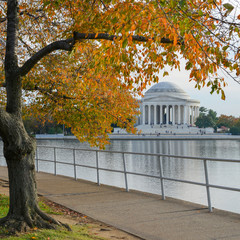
[{"left": 0, "top": 0, "right": 240, "bottom": 147}]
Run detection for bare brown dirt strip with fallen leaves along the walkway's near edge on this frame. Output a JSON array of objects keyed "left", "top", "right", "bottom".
[{"left": 0, "top": 179, "right": 140, "bottom": 240}]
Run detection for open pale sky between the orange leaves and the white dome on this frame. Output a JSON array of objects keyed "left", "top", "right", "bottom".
[{"left": 143, "top": 67, "right": 240, "bottom": 117}]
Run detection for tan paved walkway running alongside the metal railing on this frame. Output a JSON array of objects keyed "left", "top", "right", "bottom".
[{"left": 0, "top": 167, "right": 240, "bottom": 240}]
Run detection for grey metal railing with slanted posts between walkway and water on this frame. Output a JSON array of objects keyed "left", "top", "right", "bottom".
[{"left": 36, "top": 145, "right": 240, "bottom": 212}]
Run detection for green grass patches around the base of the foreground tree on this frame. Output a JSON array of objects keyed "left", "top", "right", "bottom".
[{"left": 0, "top": 194, "right": 103, "bottom": 240}]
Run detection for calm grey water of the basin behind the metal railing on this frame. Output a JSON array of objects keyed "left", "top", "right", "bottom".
[{"left": 0, "top": 140, "right": 240, "bottom": 213}]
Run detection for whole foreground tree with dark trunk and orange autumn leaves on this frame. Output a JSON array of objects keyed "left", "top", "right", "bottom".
[{"left": 0, "top": 0, "right": 240, "bottom": 233}]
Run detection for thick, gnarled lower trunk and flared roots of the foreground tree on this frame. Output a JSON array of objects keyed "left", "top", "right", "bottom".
[{"left": 0, "top": 114, "right": 69, "bottom": 233}]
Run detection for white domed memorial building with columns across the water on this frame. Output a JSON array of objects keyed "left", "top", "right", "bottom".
[{"left": 138, "top": 82, "right": 200, "bottom": 128}]
